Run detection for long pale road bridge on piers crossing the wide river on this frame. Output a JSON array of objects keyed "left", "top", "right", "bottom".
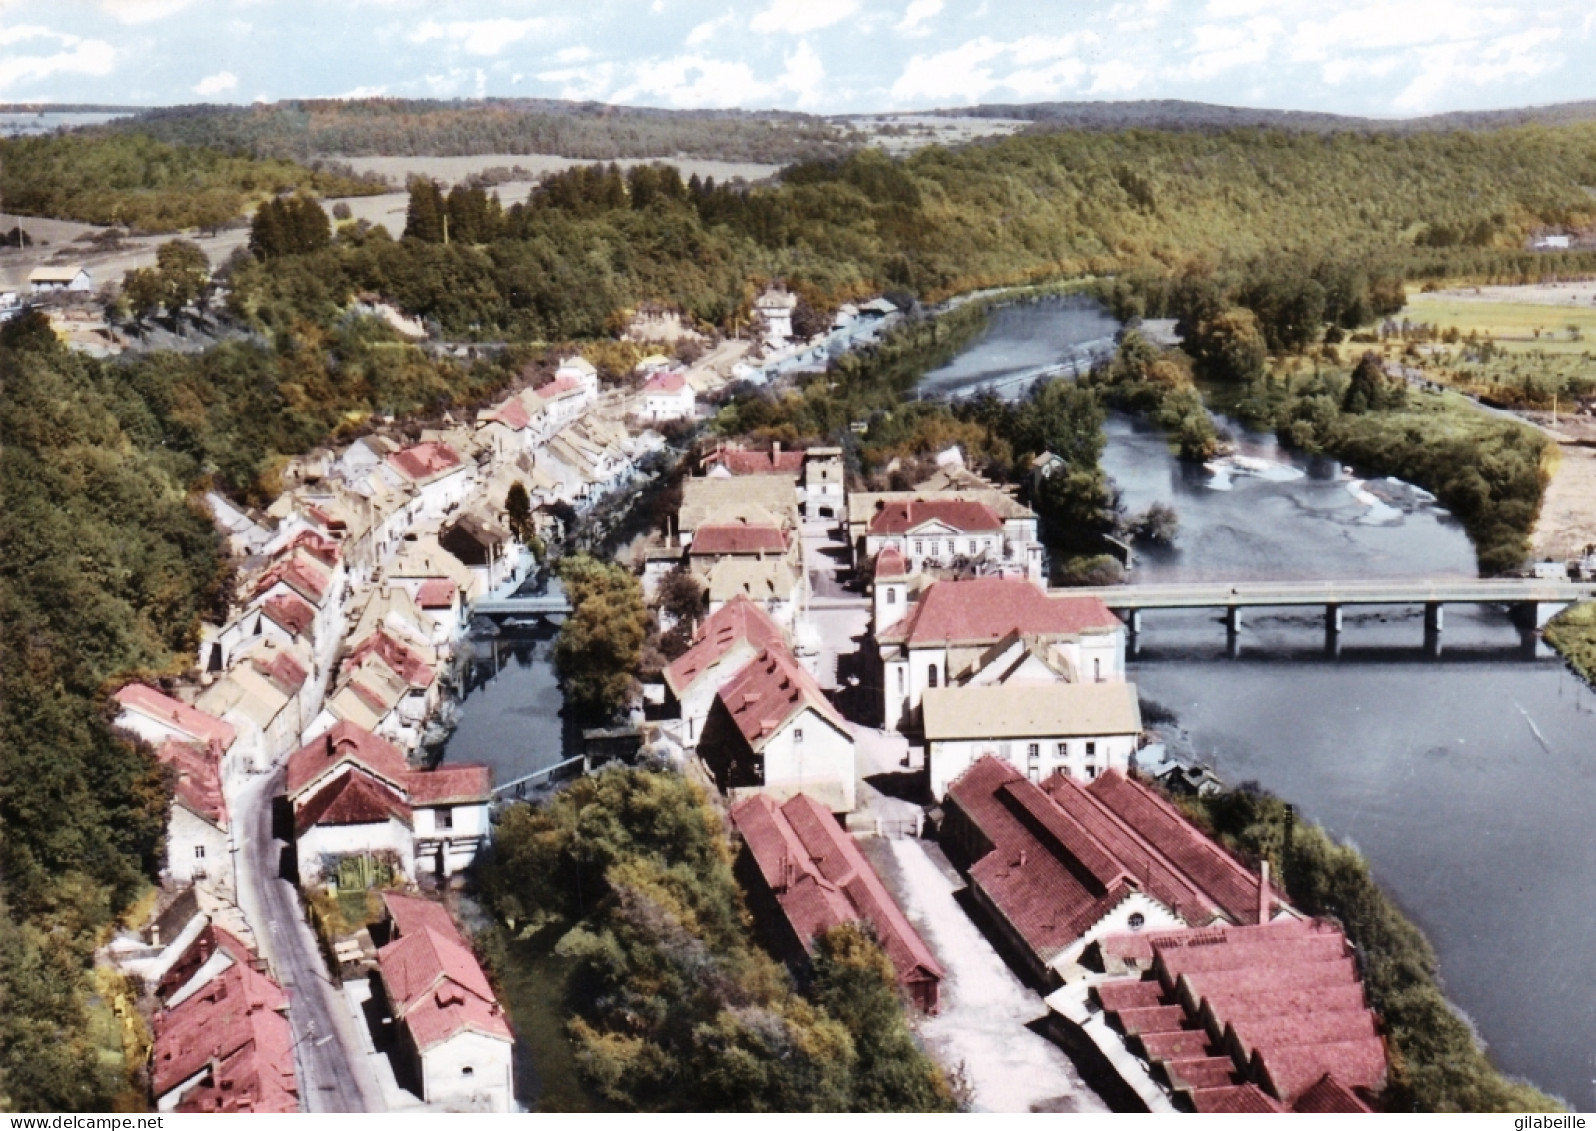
[{"left": 1068, "top": 577, "right": 1596, "bottom": 640}]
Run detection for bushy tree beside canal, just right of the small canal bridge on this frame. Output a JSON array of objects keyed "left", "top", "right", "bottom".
[{"left": 554, "top": 554, "right": 648, "bottom": 718}]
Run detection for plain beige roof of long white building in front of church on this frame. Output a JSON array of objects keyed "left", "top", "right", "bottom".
[{"left": 924, "top": 683, "right": 1141, "bottom": 742}]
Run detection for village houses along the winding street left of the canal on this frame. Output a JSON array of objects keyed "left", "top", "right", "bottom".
[{"left": 98, "top": 350, "right": 699, "bottom": 1112}]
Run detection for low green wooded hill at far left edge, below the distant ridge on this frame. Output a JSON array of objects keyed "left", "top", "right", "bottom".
[{"left": 0, "top": 134, "right": 383, "bottom": 231}]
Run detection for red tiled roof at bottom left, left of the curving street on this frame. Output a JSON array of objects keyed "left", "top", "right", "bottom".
[{"left": 150, "top": 964, "right": 298, "bottom": 1112}]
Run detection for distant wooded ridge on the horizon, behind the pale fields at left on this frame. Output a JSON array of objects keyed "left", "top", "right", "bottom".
[{"left": 101, "top": 99, "right": 857, "bottom": 164}]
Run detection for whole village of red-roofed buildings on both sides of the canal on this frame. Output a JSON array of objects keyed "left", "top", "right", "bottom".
[{"left": 107, "top": 282, "right": 1387, "bottom": 1112}]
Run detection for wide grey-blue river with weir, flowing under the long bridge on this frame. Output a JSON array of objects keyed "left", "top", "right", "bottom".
[{"left": 922, "top": 300, "right": 1596, "bottom": 1110}]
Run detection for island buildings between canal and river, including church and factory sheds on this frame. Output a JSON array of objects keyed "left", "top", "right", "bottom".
[{"left": 645, "top": 447, "right": 1385, "bottom": 1112}]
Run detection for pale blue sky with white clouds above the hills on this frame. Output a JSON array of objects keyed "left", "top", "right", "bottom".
[{"left": 0, "top": 0, "right": 1596, "bottom": 116}]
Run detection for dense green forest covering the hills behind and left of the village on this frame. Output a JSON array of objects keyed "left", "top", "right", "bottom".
[{"left": 0, "top": 117, "right": 1596, "bottom": 1110}]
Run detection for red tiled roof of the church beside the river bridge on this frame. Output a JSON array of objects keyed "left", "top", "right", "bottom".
[{"left": 881, "top": 577, "right": 1122, "bottom": 648}]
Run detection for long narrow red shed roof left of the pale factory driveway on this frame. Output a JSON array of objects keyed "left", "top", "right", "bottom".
[{"left": 731, "top": 793, "right": 943, "bottom": 1001}]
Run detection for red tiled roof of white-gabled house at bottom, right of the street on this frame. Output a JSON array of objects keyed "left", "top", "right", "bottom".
[{"left": 377, "top": 924, "right": 511, "bottom": 1053}]
